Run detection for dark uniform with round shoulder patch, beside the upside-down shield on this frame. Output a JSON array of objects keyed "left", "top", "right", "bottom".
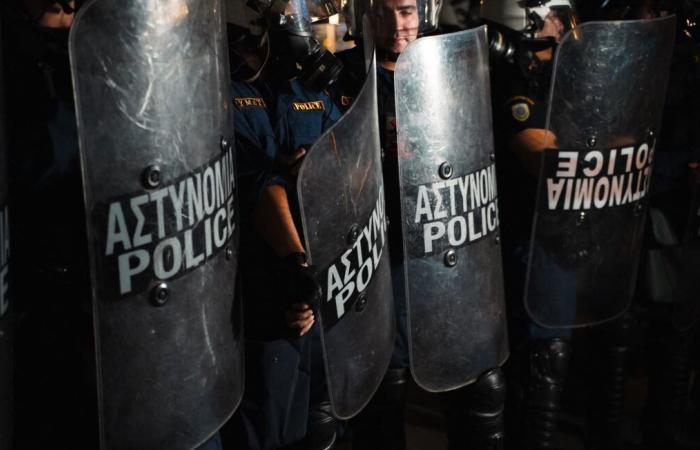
[{"left": 492, "top": 64, "right": 575, "bottom": 347}]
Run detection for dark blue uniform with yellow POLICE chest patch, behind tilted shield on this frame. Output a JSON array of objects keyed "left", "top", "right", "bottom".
[{"left": 231, "top": 74, "right": 340, "bottom": 449}]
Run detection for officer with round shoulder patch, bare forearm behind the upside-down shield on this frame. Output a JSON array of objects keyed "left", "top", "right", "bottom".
[{"left": 486, "top": 2, "right": 570, "bottom": 448}]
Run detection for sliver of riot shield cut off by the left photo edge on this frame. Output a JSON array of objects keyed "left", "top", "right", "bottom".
[{"left": 0, "top": 29, "right": 14, "bottom": 449}]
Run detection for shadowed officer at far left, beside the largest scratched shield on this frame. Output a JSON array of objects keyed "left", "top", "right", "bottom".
[{"left": 2, "top": 0, "right": 97, "bottom": 448}]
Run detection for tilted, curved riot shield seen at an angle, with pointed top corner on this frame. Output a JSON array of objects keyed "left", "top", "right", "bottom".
[{"left": 297, "top": 50, "right": 394, "bottom": 419}]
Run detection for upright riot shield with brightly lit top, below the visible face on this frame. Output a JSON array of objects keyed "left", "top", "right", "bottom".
[{"left": 394, "top": 27, "right": 508, "bottom": 391}]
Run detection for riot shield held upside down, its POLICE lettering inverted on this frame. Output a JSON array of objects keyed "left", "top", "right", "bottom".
[{"left": 525, "top": 17, "right": 675, "bottom": 328}]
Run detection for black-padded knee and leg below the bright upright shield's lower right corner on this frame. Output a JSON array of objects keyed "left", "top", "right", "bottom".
[{"left": 447, "top": 367, "right": 506, "bottom": 450}]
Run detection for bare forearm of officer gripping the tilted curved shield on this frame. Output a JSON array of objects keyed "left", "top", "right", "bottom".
[{"left": 253, "top": 184, "right": 304, "bottom": 258}]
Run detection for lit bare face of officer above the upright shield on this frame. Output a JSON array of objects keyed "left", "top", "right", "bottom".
[{"left": 372, "top": 0, "right": 419, "bottom": 54}]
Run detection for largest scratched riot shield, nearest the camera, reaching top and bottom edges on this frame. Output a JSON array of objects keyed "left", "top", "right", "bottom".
[{"left": 70, "top": 0, "right": 243, "bottom": 449}]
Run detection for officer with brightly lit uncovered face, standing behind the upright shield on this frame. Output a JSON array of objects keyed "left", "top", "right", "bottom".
[{"left": 332, "top": 0, "right": 505, "bottom": 449}]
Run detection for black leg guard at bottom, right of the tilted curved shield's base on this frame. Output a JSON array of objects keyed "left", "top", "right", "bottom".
[{"left": 350, "top": 369, "right": 408, "bottom": 450}]
